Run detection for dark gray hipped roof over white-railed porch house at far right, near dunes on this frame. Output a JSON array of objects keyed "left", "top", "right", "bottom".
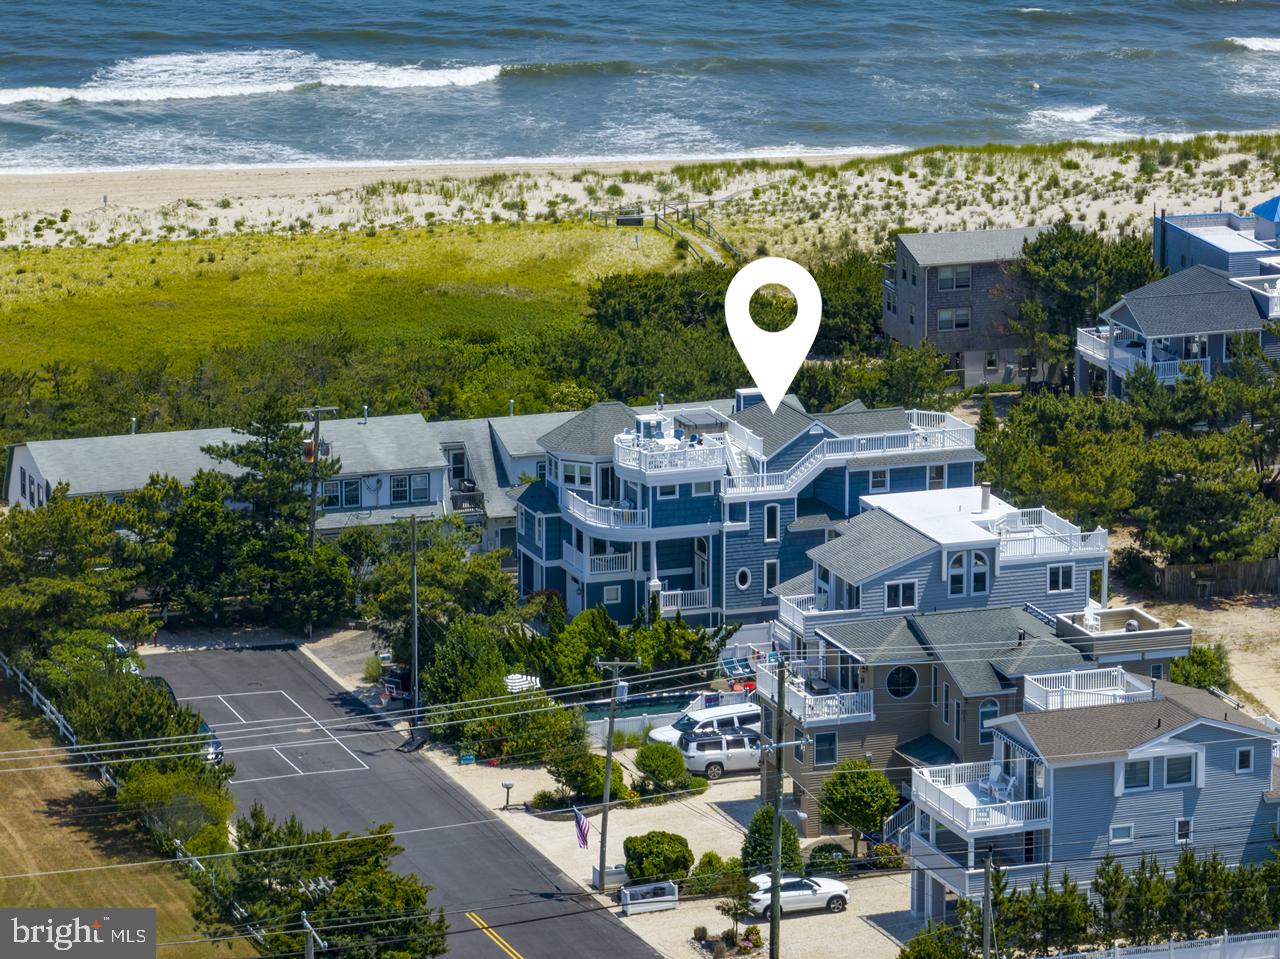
[{"left": 1111, "top": 264, "right": 1263, "bottom": 337}]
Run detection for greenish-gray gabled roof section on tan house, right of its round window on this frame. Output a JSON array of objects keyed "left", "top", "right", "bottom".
[{"left": 913, "top": 606, "right": 1064, "bottom": 697}]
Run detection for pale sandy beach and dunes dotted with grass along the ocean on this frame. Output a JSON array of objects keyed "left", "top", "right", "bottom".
[{"left": 0, "top": 137, "right": 1276, "bottom": 255}]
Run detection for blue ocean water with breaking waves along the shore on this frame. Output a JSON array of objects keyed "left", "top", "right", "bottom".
[{"left": 0, "top": 0, "right": 1280, "bottom": 171}]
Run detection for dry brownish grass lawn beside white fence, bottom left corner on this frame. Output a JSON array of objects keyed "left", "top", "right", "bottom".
[{"left": 0, "top": 684, "right": 256, "bottom": 959}]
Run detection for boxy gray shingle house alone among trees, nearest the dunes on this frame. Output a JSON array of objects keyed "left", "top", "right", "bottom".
[{"left": 882, "top": 227, "right": 1051, "bottom": 387}]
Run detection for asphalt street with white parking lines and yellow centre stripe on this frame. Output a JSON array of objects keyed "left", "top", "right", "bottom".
[{"left": 147, "top": 649, "right": 658, "bottom": 959}]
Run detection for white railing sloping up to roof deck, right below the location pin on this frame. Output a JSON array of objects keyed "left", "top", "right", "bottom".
[{"left": 724, "top": 410, "right": 974, "bottom": 494}]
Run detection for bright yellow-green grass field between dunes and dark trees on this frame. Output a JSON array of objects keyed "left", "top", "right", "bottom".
[{"left": 0, "top": 223, "right": 676, "bottom": 370}]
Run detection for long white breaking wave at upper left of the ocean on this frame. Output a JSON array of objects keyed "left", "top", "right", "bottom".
[{"left": 0, "top": 50, "right": 502, "bottom": 105}]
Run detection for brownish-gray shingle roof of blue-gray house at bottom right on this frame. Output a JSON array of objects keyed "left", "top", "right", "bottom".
[{"left": 1016, "top": 682, "right": 1270, "bottom": 763}]
